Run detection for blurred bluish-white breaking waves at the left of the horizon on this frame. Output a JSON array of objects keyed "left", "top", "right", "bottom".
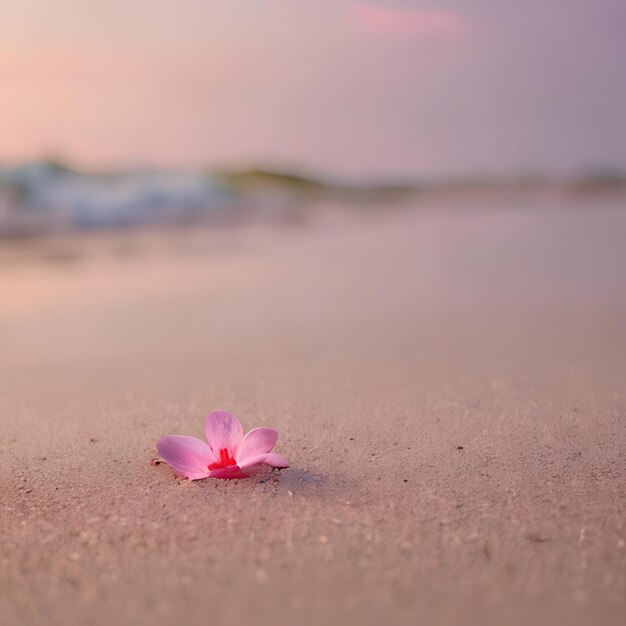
[{"left": 0, "top": 163, "right": 232, "bottom": 236}]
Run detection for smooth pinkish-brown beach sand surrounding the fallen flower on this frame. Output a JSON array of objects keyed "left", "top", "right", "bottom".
[{"left": 0, "top": 198, "right": 626, "bottom": 626}]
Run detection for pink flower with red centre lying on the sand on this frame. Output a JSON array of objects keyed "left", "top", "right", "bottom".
[{"left": 156, "top": 411, "right": 289, "bottom": 480}]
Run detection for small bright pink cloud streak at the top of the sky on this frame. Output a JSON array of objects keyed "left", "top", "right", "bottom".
[{"left": 350, "top": 4, "right": 467, "bottom": 38}]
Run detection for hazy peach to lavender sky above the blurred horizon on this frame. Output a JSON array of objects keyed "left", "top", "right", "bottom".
[{"left": 0, "top": 0, "right": 626, "bottom": 177}]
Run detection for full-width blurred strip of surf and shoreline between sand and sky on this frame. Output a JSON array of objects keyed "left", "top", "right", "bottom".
[{"left": 0, "top": 160, "right": 626, "bottom": 239}]
